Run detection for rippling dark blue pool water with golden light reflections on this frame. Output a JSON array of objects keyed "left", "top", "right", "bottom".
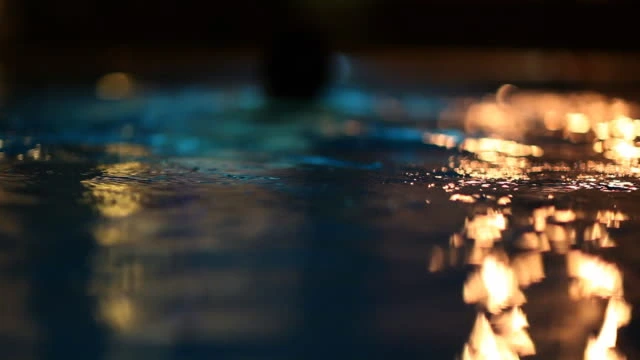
[{"left": 0, "top": 82, "right": 640, "bottom": 360}]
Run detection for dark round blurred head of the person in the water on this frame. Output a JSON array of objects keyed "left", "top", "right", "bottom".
[{"left": 261, "top": 24, "right": 331, "bottom": 101}]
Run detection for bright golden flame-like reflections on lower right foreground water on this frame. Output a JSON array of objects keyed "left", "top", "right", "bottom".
[{"left": 428, "top": 195, "right": 631, "bottom": 360}]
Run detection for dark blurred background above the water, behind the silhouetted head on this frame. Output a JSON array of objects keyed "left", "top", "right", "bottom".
[{"left": 0, "top": 0, "right": 640, "bottom": 93}]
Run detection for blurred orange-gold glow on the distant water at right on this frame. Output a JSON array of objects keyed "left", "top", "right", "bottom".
[{"left": 432, "top": 85, "right": 640, "bottom": 172}]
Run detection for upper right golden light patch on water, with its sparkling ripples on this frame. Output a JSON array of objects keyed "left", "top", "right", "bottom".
[{"left": 416, "top": 85, "right": 640, "bottom": 179}]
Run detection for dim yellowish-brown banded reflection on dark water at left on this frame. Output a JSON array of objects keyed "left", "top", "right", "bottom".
[{"left": 84, "top": 163, "right": 301, "bottom": 359}]
